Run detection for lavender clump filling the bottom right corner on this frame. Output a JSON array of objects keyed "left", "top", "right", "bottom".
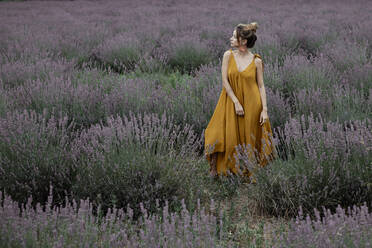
[{"left": 268, "top": 204, "right": 372, "bottom": 248}]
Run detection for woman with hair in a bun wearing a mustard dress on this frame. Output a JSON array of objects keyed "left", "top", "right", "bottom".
[{"left": 205, "top": 22, "right": 276, "bottom": 180}]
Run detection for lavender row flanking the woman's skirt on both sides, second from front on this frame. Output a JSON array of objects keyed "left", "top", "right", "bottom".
[{"left": 0, "top": 105, "right": 372, "bottom": 222}]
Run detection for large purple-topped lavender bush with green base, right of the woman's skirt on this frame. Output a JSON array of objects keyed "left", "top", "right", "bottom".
[{"left": 247, "top": 114, "right": 372, "bottom": 216}]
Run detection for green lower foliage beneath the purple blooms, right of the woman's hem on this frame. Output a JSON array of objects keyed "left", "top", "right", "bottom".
[{"left": 252, "top": 151, "right": 372, "bottom": 217}]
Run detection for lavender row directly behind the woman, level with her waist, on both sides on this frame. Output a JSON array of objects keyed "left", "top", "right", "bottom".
[{"left": 1, "top": 59, "right": 372, "bottom": 139}]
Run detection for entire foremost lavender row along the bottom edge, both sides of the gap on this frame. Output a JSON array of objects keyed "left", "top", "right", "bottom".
[{"left": 0, "top": 186, "right": 372, "bottom": 247}]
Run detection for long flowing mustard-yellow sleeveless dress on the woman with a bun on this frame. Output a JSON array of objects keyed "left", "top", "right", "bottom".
[{"left": 204, "top": 49, "right": 277, "bottom": 177}]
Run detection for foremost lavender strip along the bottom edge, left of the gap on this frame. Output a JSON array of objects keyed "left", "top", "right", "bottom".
[{"left": 0, "top": 186, "right": 231, "bottom": 247}]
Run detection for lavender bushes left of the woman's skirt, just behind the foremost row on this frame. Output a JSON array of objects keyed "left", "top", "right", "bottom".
[{"left": 0, "top": 110, "right": 202, "bottom": 222}]
